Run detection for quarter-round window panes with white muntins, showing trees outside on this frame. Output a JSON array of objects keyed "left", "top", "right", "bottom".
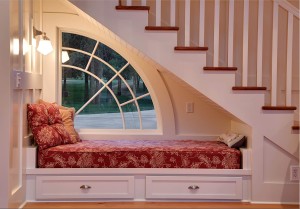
[{"left": 61, "top": 32, "right": 157, "bottom": 129}]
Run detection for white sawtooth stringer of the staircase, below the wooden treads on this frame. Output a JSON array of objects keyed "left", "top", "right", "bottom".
[{"left": 71, "top": 0, "right": 299, "bottom": 158}]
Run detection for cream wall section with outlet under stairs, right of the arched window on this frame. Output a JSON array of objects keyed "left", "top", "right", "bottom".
[{"left": 161, "top": 72, "right": 235, "bottom": 137}]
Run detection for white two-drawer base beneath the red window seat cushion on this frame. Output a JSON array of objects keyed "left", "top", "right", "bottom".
[{"left": 26, "top": 168, "right": 252, "bottom": 202}]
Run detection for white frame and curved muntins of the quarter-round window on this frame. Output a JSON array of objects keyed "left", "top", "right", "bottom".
[{"left": 56, "top": 28, "right": 162, "bottom": 135}]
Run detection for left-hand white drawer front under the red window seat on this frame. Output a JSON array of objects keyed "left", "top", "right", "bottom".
[{"left": 36, "top": 176, "right": 134, "bottom": 199}]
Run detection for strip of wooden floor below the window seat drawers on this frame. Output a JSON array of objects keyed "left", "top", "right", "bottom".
[{"left": 24, "top": 202, "right": 299, "bottom": 209}]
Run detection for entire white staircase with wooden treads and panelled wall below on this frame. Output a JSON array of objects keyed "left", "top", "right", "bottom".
[{"left": 62, "top": 0, "right": 299, "bottom": 202}]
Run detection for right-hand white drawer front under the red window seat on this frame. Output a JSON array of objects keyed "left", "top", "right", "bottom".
[{"left": 146, "top": 176, "right": 242, "bottom": 199}]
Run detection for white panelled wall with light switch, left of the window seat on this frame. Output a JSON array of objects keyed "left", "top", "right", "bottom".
[{"left": 0, "top": 0, "right": 35, "bottom": 208}]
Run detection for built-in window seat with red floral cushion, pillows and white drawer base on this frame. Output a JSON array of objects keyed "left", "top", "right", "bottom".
[{"left": 26, "top": 103, "right": 251, "bottom": 201}]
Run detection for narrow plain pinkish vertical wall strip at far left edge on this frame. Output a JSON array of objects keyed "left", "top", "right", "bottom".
[{"left": 0, "top": 1, "right": 11, "bottom": 208}]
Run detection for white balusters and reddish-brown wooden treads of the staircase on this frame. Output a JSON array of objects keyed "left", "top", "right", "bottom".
[{"left": 116, "top": 0, "right": 299, "bottom": 121}]
